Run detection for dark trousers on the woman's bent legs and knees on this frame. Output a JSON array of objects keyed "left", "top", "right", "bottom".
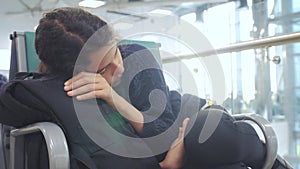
[{"left": 184, "top": 108, "right": 266, "bottom": 169}]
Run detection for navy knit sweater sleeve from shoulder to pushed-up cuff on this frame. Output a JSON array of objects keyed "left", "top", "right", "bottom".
[{"left": 121, "top": 44, "right": 176, "bottom": 137}]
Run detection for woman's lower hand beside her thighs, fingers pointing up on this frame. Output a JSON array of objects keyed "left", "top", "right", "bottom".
[{"left": 160, "top": 118, "right": 189, "bottom": 169}]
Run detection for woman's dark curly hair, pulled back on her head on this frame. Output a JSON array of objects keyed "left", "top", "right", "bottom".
[{"left": 35, "top": 7, "right": 114, "bottom": 76}]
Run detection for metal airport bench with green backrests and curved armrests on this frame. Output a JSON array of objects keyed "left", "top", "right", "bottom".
[{"left": 0, "top": 32, "right": 277, "bottom": 169}]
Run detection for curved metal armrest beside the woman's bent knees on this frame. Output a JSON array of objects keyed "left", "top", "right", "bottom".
[{"left": 233, "top": 114, "right": 278, "bottom": 169}]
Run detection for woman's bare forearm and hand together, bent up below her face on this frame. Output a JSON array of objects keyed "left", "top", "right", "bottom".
[{"left": 64, "top": 72, "right": 144, "bottom": 133}]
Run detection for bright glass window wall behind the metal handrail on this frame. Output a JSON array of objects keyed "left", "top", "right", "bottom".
[{"left": 129, "top": 0, "right": 300, "bottom": 168}]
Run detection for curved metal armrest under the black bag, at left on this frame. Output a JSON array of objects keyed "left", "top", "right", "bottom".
[{"left": 10, "top": 122, "right": 70, "bottom": 169}]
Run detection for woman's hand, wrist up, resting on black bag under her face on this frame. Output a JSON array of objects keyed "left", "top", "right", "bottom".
[{"left": 64, "top": 72, "right": 116, "bottom": 107}]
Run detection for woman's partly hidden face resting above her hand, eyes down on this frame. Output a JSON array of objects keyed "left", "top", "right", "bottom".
[{"left": 87, "top": 42, "right": 124, "bottom": 86}]
